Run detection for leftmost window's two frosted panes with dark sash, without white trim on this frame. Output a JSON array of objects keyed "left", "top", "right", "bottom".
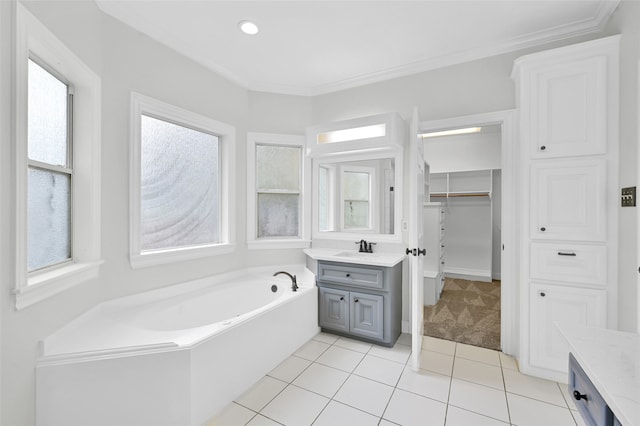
[{"left": 27, "top": 59, "right": 73, "bottom": 272}]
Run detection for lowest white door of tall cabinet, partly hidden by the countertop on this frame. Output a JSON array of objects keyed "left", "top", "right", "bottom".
[{"left": 529, "top": 283, "right": 607, "bottom": 373}]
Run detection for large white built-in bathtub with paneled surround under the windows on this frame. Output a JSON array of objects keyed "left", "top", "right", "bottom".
[{"left": 36, "top": 265, "right": 319, "bottom": 426}]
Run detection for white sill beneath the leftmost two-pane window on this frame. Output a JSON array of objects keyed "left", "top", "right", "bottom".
[{"left": 14, "top": 260, "right": 104, "bottom": 310}]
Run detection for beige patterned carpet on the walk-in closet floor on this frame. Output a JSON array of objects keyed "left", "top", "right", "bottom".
[{"left": 424, "top": 278, "right": 500, "bottom": 350}]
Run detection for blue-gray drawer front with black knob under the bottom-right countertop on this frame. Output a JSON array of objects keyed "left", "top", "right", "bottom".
[{"left": 569, "top": 353, "right": 613, "bottom": 426}]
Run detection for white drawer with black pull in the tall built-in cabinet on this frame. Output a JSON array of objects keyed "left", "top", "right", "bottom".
[{"left": 531, "top": 243, "right": 607, "bottom": 286}]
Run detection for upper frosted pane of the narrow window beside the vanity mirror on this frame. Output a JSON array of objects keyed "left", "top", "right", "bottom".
[{"left": 256, "top": 145, "right": 302, "bottom": 191}]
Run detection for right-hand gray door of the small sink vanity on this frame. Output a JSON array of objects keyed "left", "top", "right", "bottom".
[{"left": 350, "top": 292, "right": 384, "bottom": 340}]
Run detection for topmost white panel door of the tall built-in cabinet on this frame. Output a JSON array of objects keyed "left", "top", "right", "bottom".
[{"left": 531, "top": 55, "right": 608, "bottom": 158}]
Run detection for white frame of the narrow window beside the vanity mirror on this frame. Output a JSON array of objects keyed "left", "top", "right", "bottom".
[{"left": 247, "top": 132, "right": 311, "bottom": 250}]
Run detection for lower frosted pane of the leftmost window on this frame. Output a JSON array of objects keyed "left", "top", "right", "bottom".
[{"left": 27, "top": 168, "right": 71, "bottom": 271}]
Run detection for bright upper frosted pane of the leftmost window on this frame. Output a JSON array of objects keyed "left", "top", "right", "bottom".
[{"left": 27, "top": 60, "right": 68, "bottom": 166}]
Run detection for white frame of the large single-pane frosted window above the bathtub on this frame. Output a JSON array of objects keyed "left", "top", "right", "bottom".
[{"left": 129, "top": 92, "right": 236, "bottom": 268}]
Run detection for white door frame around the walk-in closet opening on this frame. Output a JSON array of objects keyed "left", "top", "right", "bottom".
[{"left": 419, "top": 110, "right": 520, "bottom": 358}]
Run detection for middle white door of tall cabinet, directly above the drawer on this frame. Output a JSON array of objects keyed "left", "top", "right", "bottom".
[{"left": 531, "top": 159, "right": 607, "bottom": 242}]
